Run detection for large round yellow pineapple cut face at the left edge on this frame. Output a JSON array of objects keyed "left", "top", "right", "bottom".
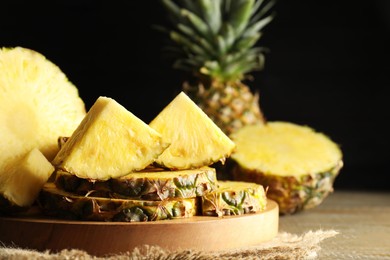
[{"left": 0, "top": 47, "right": 86, "bottom": 175}]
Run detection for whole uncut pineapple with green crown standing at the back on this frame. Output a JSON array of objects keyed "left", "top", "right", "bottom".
[{"left": 158, "top": 0, "right": 274, "bottom": 135}]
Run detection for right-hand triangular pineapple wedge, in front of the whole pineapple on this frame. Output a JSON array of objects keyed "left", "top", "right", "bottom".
[{"left": 149, "top": 92, "right": 235, "bottom": 170}]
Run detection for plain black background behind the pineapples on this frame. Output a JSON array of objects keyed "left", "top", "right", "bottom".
[{"left": 0, "top": 0, "right": 390, "bottom": 190}]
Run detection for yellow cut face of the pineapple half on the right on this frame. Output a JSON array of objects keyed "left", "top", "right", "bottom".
[{"left": 232, "top": 122, "right": 341, "bottom": 177}]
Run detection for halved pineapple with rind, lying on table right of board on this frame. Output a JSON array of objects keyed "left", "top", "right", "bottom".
[{"left": 231, "top": 122, "right": 343, "bottom": 214}]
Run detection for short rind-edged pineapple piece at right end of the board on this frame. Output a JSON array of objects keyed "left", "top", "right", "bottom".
[{"left": 202, "top": 181, "right": 267, "bottom": 217}]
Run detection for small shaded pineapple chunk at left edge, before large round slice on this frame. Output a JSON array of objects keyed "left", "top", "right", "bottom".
[{"left": 0, "top": 148, "right": 54, "bottom": 208}]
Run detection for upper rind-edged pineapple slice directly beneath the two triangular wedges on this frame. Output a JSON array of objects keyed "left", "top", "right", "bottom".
[{"left": 54, "top": 167, "right": 217, "bottom": 200}]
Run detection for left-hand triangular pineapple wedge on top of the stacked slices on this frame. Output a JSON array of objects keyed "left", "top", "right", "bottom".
[{"left": 53, "top": 96, "right": 168, "bottom": 180}]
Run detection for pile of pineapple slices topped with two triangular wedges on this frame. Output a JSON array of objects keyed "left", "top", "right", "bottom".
[{"left": 38, "top": 92, "right": 267, "bottom": 221}]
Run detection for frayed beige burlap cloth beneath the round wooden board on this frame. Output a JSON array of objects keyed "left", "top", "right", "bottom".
[{"left": 0, "top": 230, "right": 338, "bottom": 260}]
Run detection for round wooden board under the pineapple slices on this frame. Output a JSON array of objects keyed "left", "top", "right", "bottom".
[{"left": 0, "top": 200, "right": 279, "bottom": 256}]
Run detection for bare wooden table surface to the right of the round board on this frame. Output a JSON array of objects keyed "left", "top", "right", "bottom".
[{"left": 279, "top": 190, "right": 390, "bottom": 260}]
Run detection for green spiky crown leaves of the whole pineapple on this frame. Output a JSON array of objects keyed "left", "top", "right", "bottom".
[{"left": 158, "top": 0, "right": 275, "bottom": 82}]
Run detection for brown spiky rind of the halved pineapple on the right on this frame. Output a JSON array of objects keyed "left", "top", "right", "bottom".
[{"left": 231, "top": 161, "right": 342, "bottom": 215}]
